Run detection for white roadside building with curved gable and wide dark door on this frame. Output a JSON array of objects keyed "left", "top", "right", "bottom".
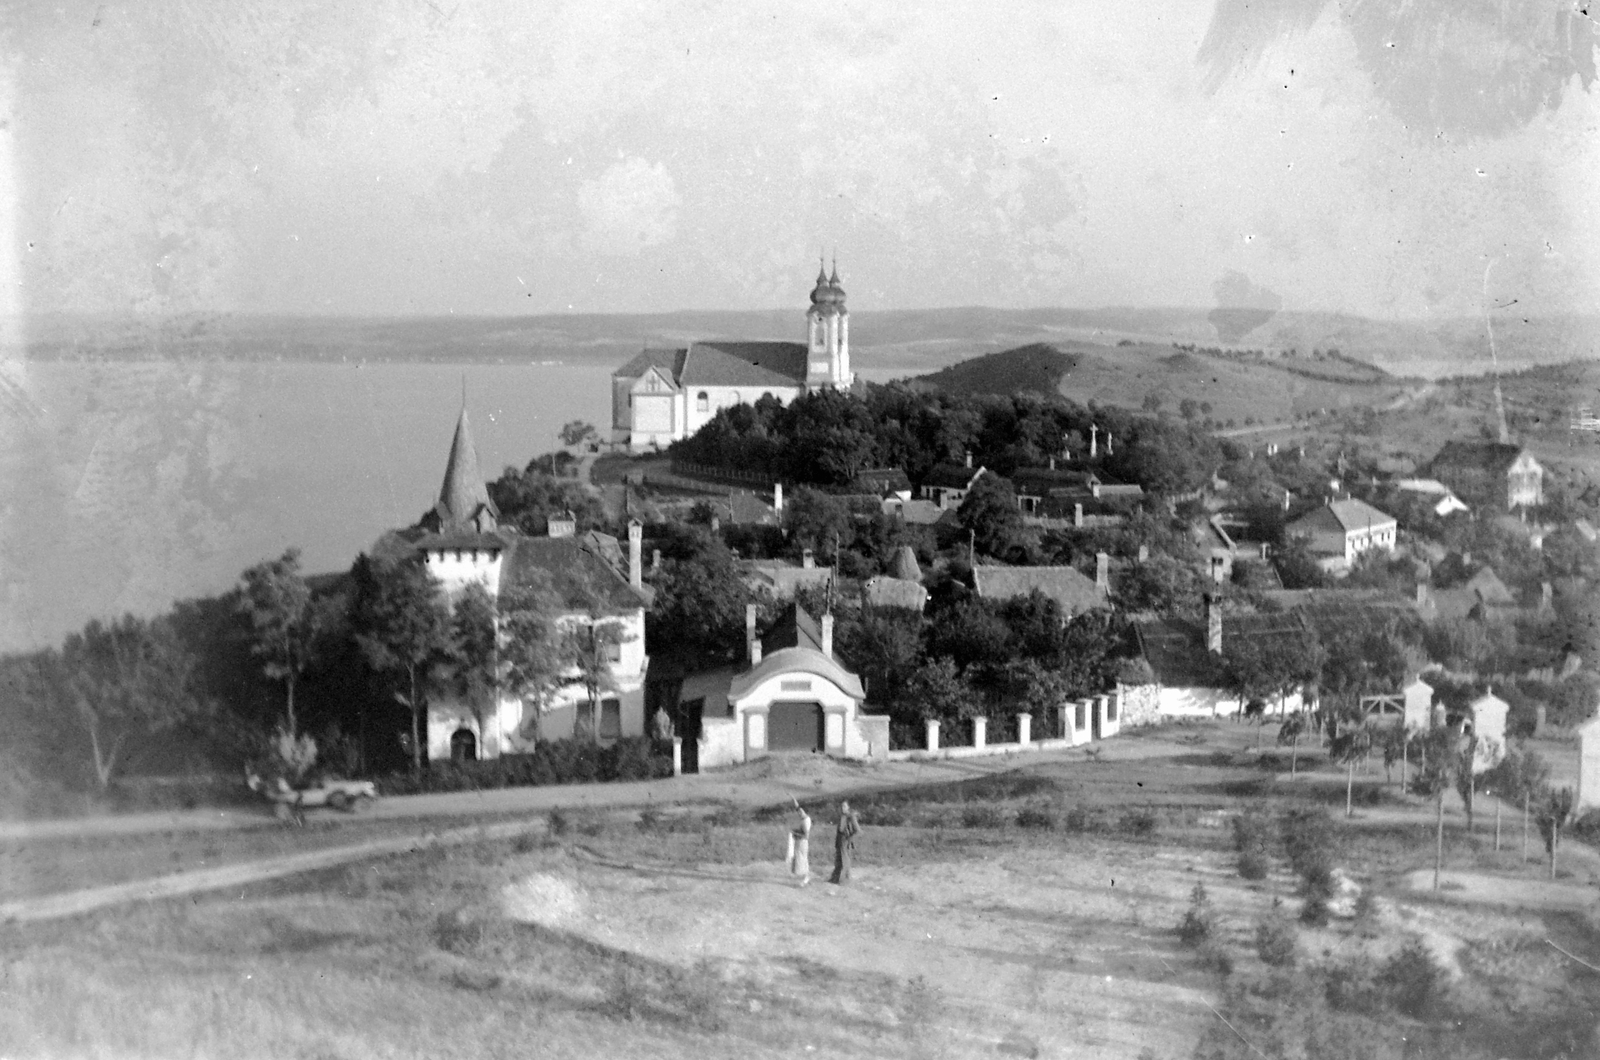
[{"left": 672, "top": 604, "right": 890, "bottom": 772}]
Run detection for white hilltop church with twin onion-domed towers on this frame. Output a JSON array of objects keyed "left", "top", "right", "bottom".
[{"left": 611, "top": 263, "right": 856, "bottom": 452}]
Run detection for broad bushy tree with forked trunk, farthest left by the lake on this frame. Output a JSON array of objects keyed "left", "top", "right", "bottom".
[{"left": 37, "top": 615, "right": 210, "bottom": 789}]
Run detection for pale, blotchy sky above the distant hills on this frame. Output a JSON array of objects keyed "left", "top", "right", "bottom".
[{"left": 0, "top": 0, "right": 1600, "bottom": 317}]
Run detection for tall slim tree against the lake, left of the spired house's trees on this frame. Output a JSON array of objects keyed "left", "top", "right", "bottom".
[{"left": 238, "top": 548, "right": 334, "bottom": 737}]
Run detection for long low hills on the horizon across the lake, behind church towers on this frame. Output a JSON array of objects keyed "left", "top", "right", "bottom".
[{"left": 15, "top": 306, "right": 1600, "bottom": 378}]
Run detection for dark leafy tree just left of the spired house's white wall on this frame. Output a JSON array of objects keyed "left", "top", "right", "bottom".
[{"left": 355, "top": 556, "right": 450, "bottom": 773}]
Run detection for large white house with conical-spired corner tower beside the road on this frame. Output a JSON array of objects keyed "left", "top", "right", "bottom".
[{"left": 409, "top": 408, "right": 653, "bottom": 759}]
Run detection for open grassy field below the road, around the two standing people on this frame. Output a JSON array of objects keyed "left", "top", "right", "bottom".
[{"left": 0, "top": 722, "right": 1600, "bottom": 1060}]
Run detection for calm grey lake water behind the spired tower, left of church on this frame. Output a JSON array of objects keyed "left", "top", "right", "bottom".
[{"left": 0, "top": 361, "right": 906, "bottom": 650}]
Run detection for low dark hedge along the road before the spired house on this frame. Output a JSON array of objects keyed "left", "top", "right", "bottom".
[{"left": 378, "top": 737, "right": 672, "bottom": 794}]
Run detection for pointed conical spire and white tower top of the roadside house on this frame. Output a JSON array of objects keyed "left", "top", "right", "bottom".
[{"left": 418, "top": 399, "right": 506, "bottom": 594}]
